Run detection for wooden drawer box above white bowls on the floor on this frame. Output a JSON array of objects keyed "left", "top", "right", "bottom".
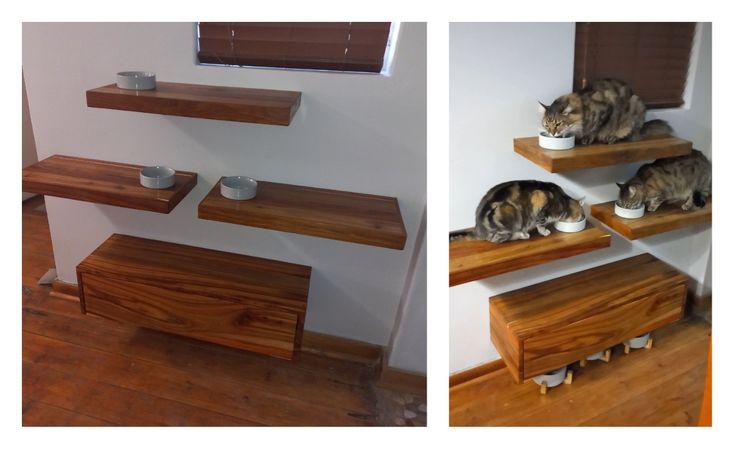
[{"left": 490, "top": 254, "right": 689, "bottom": 383}]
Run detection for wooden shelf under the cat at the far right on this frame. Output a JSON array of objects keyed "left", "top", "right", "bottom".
[{"left": 591, "top": 198, "right": 712, "bottom": 240}]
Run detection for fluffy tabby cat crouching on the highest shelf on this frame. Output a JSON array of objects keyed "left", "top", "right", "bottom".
[{"left": 539, "top": 78, "right": 673, "bottom": 144}]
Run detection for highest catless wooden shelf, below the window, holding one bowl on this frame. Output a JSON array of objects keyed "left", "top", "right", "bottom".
[{"left": 87, "top": 81, "right": 301, "bottom": 125}]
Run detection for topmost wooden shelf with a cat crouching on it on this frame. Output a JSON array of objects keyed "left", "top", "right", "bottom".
[{"left": 513, "top": 136, "right": 692, "bottom": 173}]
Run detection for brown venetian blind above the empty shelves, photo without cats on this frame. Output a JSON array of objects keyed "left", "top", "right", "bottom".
[{"left": 198, "top": 22, "right": 391, "bottom": 72}]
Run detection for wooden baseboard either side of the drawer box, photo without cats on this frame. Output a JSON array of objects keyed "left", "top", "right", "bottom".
[{"left": 51, "top": 279, "right": 383, "bottom": 366}]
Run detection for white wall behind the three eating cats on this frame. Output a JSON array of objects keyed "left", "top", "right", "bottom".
[{"left": 449, "top": 23, "right": 712, "bottom": 373}]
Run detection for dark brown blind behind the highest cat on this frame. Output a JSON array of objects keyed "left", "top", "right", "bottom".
[{"left": 574, "top": 22, "right": 695, "bottom": 108}]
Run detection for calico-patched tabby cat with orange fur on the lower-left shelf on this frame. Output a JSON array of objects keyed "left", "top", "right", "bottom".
[{"left": 449, "top": 180, "right": 584, "bottom": 242}]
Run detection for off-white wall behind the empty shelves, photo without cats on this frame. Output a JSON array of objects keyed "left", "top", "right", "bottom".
[{"left": 23, "top": 23, "right": 426, "bottom": 358}]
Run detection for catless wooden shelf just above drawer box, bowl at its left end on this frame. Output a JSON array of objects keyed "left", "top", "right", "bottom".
[{"left": 199, "top": 180, "right": 406, "bottom": 250}]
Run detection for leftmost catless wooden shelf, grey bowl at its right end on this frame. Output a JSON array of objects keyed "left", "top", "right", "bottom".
[{"left": 23, "top": 155, "right": 197, "bottom": 214}]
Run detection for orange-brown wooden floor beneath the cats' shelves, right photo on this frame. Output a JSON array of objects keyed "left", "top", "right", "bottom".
[{"left": 449, "top": 318, "right": 711, "bottom": 426}]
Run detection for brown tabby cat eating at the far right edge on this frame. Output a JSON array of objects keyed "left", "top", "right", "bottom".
[{"left": 617, "top": 150, "right": 712, "bottom": 211}]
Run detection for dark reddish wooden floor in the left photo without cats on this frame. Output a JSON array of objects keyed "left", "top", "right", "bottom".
[{"left": 23, "top": 199, "right": 426, "bottom": 426}]
